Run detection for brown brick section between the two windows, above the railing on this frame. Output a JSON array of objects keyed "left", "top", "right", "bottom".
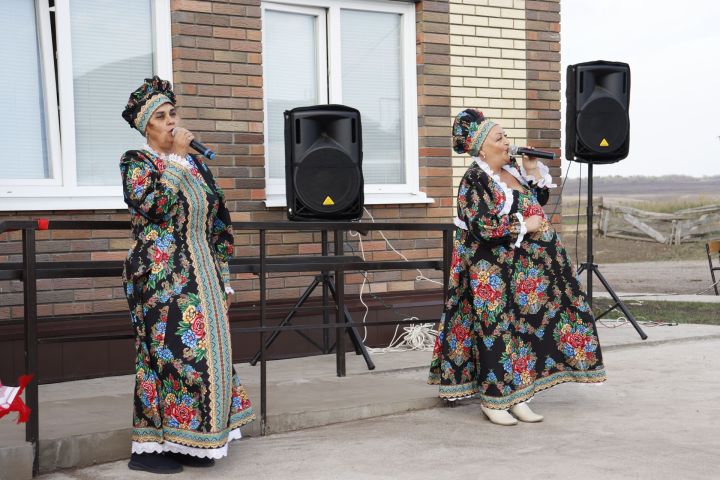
[{"left": 172, "top": 0, "right": 265, "bottom": 220}]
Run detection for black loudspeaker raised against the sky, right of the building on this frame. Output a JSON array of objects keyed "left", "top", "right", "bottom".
[{"left": 565, "top": 60, "right": 630, "bottom": 163}]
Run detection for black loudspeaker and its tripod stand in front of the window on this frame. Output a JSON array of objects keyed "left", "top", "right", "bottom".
[{"left": 250, "top": 105, "right": 375, "bottom": 375}]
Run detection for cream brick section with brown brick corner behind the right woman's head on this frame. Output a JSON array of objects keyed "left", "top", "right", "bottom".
[{"left": 447, "top": 0, "right": 560, "bottom": 203}]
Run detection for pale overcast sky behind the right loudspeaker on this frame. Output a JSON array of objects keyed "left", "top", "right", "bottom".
[{"left": 560, "top": 0, "right": 720, "bottom": 177}]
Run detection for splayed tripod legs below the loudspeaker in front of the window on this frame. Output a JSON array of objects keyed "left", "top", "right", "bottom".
[{"left": 250, "top": 273, "right": 375, "bottom": 370}]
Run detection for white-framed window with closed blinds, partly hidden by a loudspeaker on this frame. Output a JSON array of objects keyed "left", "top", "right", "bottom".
[{"left": 263, "top": 0, "right": 432, "bottom": 206}]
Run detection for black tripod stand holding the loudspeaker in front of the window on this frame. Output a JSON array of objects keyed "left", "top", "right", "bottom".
[{"left": 250, "top": 230, "right": 375, "bottom": 376}]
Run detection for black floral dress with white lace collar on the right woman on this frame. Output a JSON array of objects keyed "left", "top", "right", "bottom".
[{"left": 428, "top": 159, "right": 605, "bottom": 409}]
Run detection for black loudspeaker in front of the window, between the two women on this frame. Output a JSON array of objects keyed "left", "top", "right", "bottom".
[{"left": 285, "top": 105, "right": 365, "bottom": 220}]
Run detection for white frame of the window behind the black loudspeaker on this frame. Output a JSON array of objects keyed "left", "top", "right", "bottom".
[{"left": 262, "top": 0, "right": 434, "bottom": 207}]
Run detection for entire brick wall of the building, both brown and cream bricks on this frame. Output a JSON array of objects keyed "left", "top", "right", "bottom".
[{"left": 0, "top": 0, "right": 560, "bottom": 320}]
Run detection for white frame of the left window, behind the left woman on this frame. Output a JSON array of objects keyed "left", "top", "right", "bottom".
[{"left": 0, "top": 0, "right": 172, "bottom": 211}]
